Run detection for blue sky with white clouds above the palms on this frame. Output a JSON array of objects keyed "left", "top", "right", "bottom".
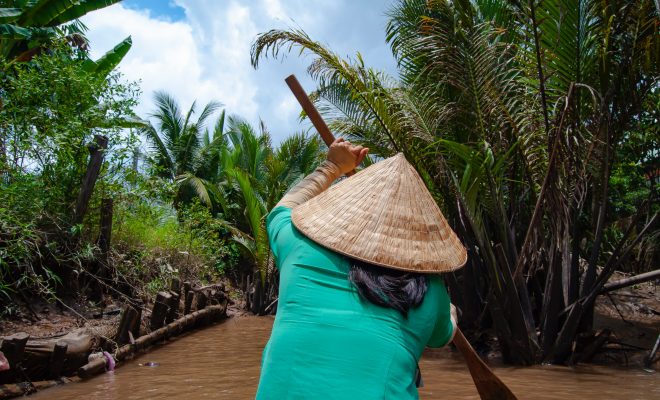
[{"left": 82, "top": 0, "right": 396, "bottom": 143}]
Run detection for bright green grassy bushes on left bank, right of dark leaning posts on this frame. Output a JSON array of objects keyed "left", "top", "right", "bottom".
[{"left": 113, "top": 198, "right": 238, "bottom": 294}]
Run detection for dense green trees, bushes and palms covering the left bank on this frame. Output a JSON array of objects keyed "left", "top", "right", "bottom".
[{"left": 0, "top": 0, "right": 321, "bottom": 316}]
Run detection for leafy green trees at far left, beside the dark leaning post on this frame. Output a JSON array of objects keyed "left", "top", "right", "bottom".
[{"left": 0, "top": 39, "right": 138, "bottom": 294}]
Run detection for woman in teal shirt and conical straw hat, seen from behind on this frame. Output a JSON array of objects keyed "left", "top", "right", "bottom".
[{"left": 257, "top": 138, "right": 467, "bottom": 400}]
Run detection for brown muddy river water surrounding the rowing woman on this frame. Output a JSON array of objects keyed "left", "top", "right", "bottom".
[{"left": 31, "top": 317, "right": 660, "bottom": 400}]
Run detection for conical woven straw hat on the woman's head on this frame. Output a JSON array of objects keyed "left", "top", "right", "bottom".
[{"left": 292, "top": 153, "right": 467, "bottom": 273}]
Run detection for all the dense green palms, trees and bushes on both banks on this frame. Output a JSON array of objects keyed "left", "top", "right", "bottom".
[{"left": 0, "top": 0, "right": 660, "bottom": 364}]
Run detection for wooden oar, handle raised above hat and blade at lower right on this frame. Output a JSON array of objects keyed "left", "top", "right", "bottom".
[{"left": 284, "top": 75, "right": 517, "bottom": 400}]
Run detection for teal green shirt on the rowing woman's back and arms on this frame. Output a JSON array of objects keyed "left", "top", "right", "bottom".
[{"left": 257, "top": 207, "right": 453, "bottom": 400}]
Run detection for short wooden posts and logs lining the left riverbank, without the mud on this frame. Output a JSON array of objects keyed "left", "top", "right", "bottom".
[{"left": 0, "top": 279, "right": 229, "bottom": 399}]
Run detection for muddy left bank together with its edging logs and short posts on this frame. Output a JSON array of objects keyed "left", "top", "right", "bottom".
[{"left": 0, "top": 280, "right": 231, "bottom": 398}]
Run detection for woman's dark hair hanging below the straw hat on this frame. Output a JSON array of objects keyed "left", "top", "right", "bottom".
[{"left": 348, "top": 260, "right": 428, "bottom": 318}]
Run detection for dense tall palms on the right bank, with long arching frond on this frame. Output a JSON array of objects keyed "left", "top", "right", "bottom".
[{"left": 252, "top": 0, "right": 660, "bottom": 364}]
